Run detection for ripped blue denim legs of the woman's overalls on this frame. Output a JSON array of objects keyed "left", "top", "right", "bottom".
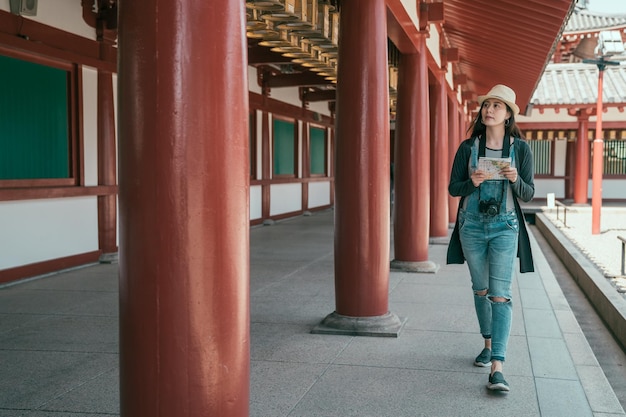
[{"left": 459, "top": 210, "right": 519, "bottom": 361}]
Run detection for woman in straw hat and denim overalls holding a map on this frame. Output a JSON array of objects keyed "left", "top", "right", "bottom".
[{"left": 447, "top": 84, "right": 535, "bottom": 392}]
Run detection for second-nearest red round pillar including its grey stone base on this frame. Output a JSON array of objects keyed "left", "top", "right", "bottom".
[{"left": 314, "top": 0, "right": 401, "bottom": 335}]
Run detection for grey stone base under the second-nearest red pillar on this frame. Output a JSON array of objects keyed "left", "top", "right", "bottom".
[{"left": 311, "top": 312, "right": 406, "bottom": 337}]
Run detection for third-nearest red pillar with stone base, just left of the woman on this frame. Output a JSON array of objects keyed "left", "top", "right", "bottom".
[{"left": 391, "top": 33, "right": 436, "bottom": 272}]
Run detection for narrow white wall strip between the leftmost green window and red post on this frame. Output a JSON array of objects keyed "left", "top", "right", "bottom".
[{"left": 82, "top": 67, "right": 98, "bottom": 186}]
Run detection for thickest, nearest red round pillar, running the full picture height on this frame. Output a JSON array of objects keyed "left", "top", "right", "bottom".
[{"left": 119, "top": 0, "right": 250, "bottom": 417}]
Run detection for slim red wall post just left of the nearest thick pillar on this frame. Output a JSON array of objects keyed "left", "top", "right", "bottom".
[{"left": 98, "top": 70, "right": 117, "bottom": 262}]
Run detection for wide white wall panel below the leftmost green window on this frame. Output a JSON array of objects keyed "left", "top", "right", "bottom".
[{"left": 0, "top": 197, "right": 98, "bottom": 270}]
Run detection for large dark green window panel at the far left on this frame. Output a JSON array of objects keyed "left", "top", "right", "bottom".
[{"left": 0, "top": 56, "right": 70, "bottom": 180}]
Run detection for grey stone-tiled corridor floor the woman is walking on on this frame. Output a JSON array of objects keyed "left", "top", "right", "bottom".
[{"left": 0, "top": 211, "right": 626, "bottom": 417}]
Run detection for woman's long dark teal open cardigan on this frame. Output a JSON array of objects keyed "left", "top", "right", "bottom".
[{"left": 446, "top": 138, "right": 535, "bottom": 272}]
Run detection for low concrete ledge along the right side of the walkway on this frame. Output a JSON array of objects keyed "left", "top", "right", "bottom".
[{"left": 535, "top": 213, "right": 626, "bottom": 346}]
